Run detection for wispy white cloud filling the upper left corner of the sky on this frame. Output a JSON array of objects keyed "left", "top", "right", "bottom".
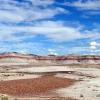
[{"left": 0, "top": 0, "right": 68, "bottom": 23}]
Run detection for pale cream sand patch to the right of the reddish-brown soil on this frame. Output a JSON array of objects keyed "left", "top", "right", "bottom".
[{"left": 56, "top": 68, "right": 100, "bottom": 100}]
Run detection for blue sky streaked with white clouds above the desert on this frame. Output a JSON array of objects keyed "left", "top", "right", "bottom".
[{"left": 0, "top": 0, "right": 100, "bottom": 55}]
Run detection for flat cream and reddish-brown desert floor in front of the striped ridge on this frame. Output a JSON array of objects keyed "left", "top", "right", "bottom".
[{"left": 0, "top": 66, "right": 100, "bottom": 100}]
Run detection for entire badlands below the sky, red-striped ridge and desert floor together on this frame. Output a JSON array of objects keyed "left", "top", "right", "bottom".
[{"left": 0, "top": 52, "right": 100, "bottom": 100}]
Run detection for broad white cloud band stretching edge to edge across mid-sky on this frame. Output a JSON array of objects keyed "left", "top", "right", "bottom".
[{"left": 0, "top": 21, "right": 100, "bottom": 42}]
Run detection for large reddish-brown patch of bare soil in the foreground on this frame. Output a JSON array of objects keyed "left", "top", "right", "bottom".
[{"left": 0, "top": 76, "right": 76, "bottom": 97}]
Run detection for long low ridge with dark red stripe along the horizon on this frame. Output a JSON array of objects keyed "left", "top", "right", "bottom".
[{"left": 0, "top": 52, "right": 100, "bottom": 65}]
